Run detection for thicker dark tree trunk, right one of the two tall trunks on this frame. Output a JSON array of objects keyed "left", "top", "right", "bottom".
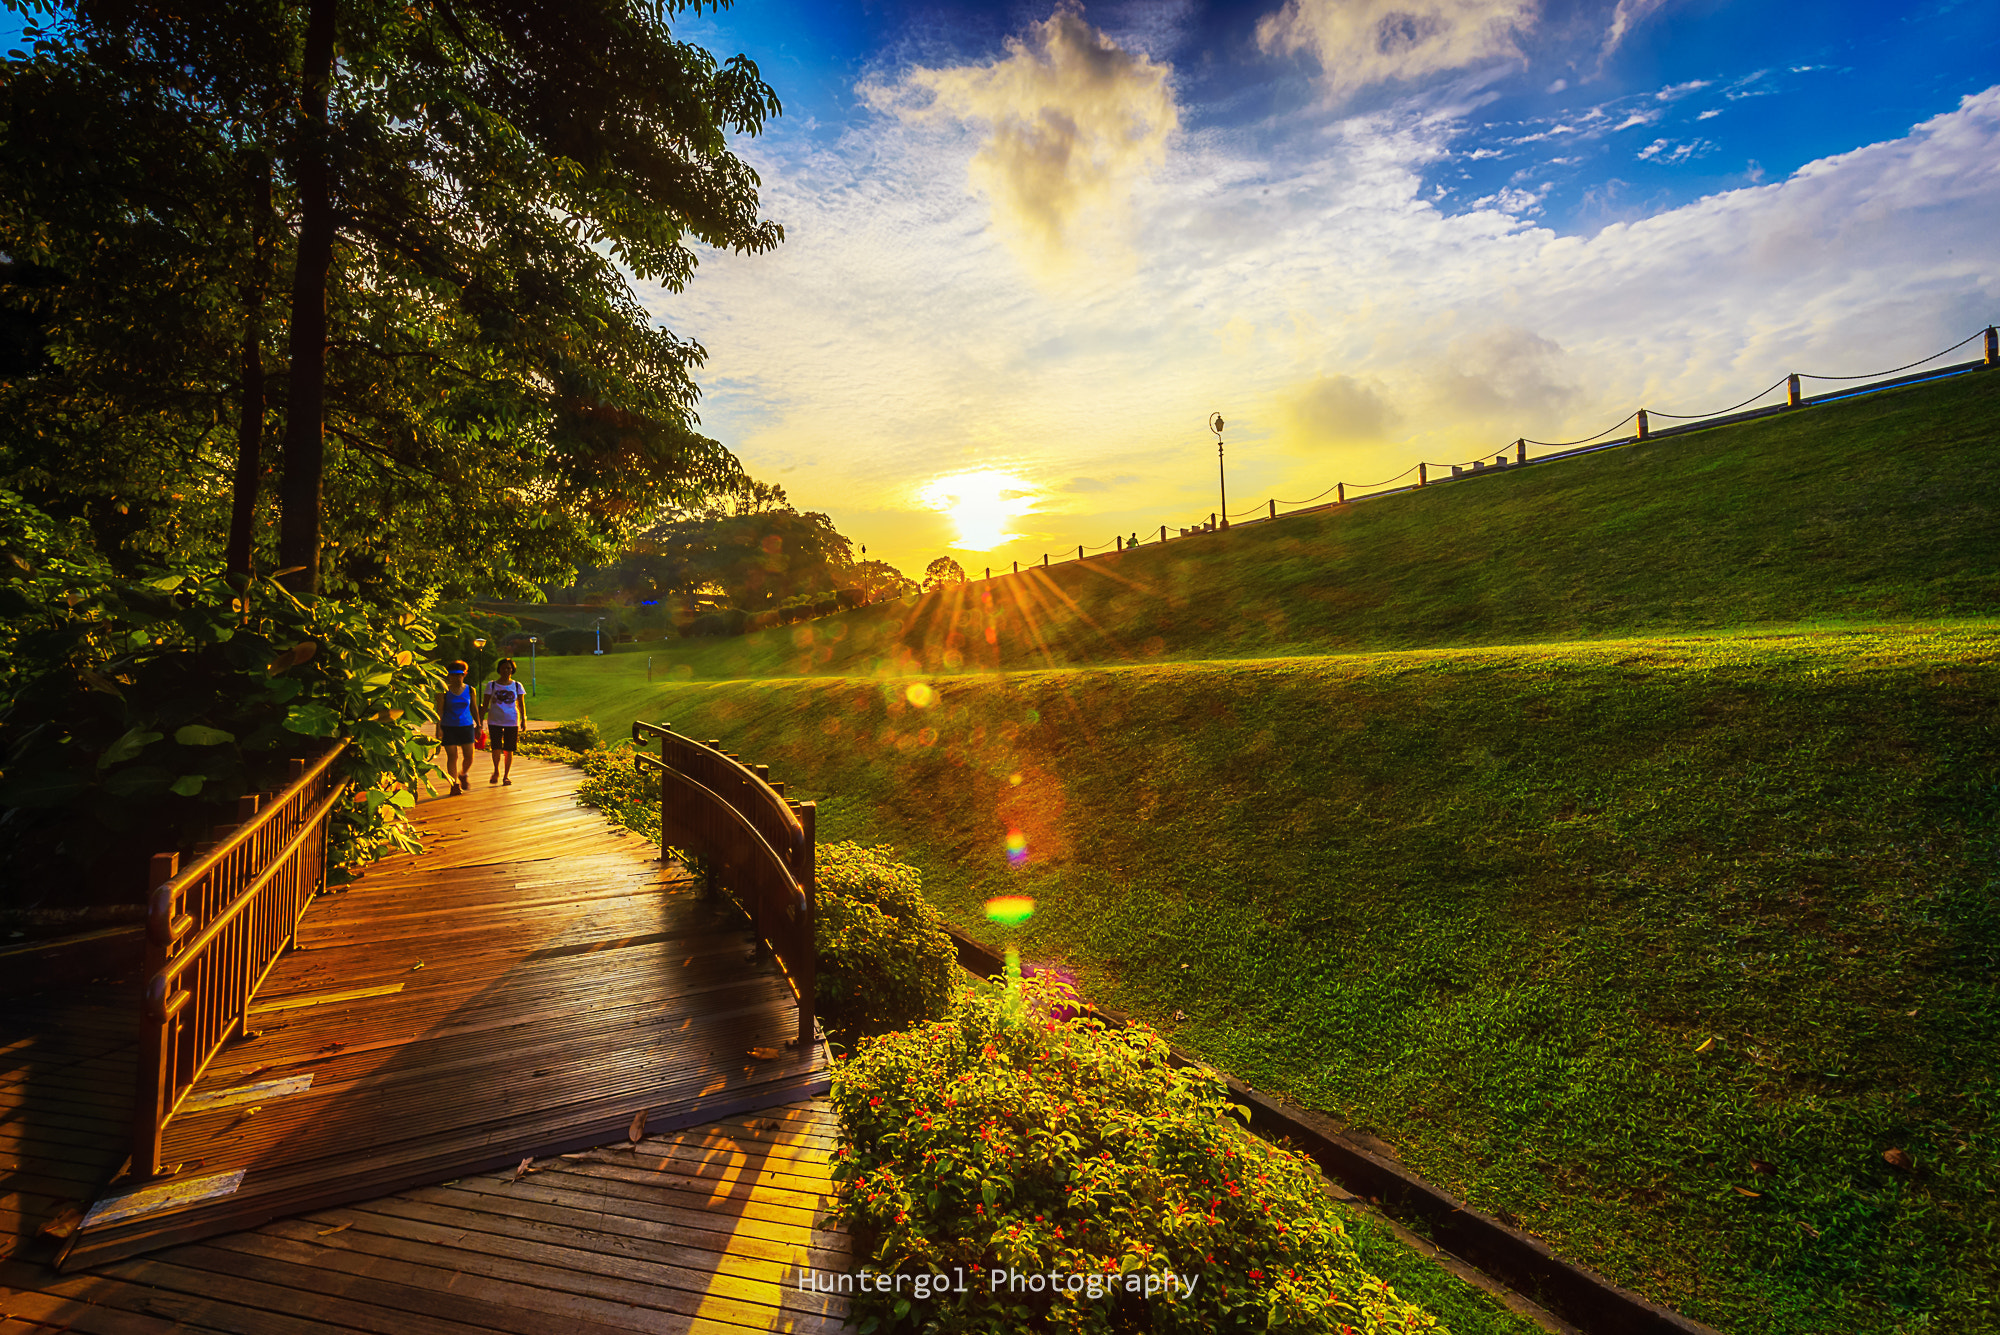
[{"left": 278, "top": 0, "right": 334, "bottom": 594}]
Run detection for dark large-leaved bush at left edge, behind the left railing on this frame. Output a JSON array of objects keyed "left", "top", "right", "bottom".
[{"left": 0, "top": 503, "right": 442, "bottom": 899}]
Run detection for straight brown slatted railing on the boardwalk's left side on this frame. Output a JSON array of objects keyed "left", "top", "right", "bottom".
[{"left": 132, "top": 741, "right": 348, "bottom": 1179}]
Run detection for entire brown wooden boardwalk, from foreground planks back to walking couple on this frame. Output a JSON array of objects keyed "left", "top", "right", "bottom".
[{"left": 0, "top": 743, "right": 848, "bottom": 1335}]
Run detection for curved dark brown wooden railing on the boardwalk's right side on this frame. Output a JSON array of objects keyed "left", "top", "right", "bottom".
[{"left": 632, "top": 723, "right": 818, "bottom": 1047}]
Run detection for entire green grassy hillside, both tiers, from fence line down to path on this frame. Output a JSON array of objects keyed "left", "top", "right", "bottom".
[{"left": 520, "top": 367, "right": 2000, "bottom": 1335}]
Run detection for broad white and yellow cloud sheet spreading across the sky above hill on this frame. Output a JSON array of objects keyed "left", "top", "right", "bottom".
[{"left": 654, "top": 88, "right": 2000, "bottom": 570}]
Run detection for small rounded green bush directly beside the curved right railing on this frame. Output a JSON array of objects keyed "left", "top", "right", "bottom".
[{"left": 814, "top": 843, "right": 958, "bottom": 1033}]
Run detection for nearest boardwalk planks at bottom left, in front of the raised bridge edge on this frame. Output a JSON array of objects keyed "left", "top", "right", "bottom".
[{"left": 0, "top": 1099, "right": 852, "bottom": 1335}]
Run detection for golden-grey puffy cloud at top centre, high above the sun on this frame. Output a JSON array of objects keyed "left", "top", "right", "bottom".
[{"left": 862, "top": 8, "right": 1180, "bottom": 274}]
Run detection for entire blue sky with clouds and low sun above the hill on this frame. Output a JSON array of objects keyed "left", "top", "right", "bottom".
[{"left": 7, "top": 0, "right": 2000, "bottom": 574}]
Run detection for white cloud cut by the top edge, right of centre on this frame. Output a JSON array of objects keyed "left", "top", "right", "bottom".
[{"left": 1256, "top": 0, "right": 1536, "bottom": 94}]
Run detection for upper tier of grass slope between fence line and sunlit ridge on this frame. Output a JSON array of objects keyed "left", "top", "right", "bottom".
[{"left": 540, "top": 367, "right": 2000, "bottom": 679}]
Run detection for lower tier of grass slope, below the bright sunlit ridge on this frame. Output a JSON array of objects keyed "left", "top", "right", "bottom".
[{"left": 540, "top": 628, "right": 2000, "bottom": 1331}]
